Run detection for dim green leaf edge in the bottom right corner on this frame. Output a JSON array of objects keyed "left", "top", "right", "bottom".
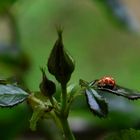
[{"left": 105, "top": 128, "right": 140, "bottom": 140}]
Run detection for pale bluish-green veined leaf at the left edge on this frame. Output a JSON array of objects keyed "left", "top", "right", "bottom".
[{"left": 0, "top": 84, "right": 29, "bottom": 107}]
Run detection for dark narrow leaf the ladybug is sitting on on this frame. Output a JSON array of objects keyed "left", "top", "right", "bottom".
[{"left": 98, "top": 85, "right": 140, "bottom": 100}]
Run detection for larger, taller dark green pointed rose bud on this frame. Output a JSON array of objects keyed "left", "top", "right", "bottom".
[{"left": 47, "top": 29, "right": 75, "bottom": 84}]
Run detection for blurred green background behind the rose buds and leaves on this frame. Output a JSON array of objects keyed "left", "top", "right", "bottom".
[{"left": 0, "top": 0, "right": 140, "bottom": 140}]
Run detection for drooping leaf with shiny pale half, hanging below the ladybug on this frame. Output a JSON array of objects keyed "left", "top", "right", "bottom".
[{"left": 85, "top": 88, "right": 108, "bottom": 117}]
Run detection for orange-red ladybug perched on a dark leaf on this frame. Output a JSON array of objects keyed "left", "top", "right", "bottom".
[{"left": 97, "top": 76, "right": 115, "bottom": 89}]
